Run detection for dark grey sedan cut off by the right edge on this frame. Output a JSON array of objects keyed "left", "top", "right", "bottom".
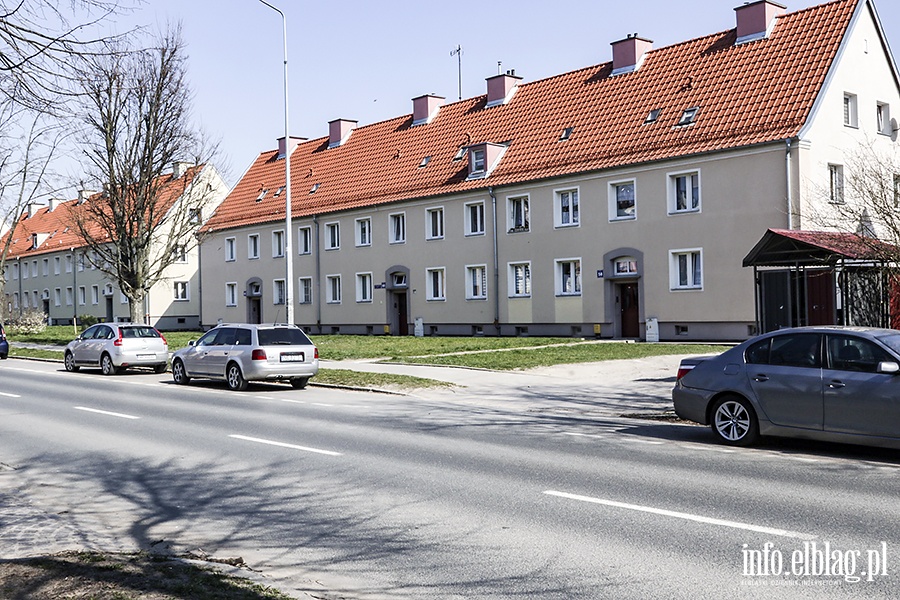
[{"left": 672, "top": 327, "right": 900, "bottom": 448}]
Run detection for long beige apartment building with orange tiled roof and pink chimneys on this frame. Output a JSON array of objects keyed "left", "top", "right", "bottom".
[{"left": 201, "top": 0, "right": 900, "bottom": 340}]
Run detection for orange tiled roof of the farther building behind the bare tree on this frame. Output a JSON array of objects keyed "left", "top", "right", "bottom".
[{"left": 0, "top": 165, "right": 203, "bottom": 259}]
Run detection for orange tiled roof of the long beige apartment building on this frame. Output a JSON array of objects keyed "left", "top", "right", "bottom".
[{"left": 207, "top": 0, "right": 858, "bottom": 229}]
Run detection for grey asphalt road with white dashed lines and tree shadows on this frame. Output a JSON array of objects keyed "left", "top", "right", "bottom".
[{"left": 0, "top": 360, "right": 900, "bottom": 599}]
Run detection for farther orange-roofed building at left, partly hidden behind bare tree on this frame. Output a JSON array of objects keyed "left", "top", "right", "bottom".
[{"left": 0, "top": 163, "right": 228, "bottom": 330}]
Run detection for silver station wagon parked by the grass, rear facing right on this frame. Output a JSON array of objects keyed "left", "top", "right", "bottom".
[{"left": 172, "top": 324, "right": 319, "bottom": 390}]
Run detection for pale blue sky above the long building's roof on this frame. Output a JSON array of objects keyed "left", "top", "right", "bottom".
[{"left": 112, "top": 0, "right": 900, "bottom": 184}]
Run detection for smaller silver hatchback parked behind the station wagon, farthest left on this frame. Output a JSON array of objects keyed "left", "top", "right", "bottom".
[{"left": 65, "top": 323, "right": 169, "bottom": 375}]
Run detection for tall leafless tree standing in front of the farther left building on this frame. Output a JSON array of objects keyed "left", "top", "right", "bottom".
[{"left": 75, "top": 28, "right": 219, "bottom": 321}]
